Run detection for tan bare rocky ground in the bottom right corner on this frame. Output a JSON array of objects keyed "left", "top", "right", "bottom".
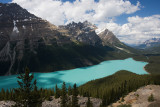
[{"left": 111, "top": 85, "right": 160, "bottom": 107}]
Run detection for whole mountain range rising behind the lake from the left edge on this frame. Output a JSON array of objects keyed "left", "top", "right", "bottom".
[{"left": 0, "top": 3, "right": 134, "bottom": 75}]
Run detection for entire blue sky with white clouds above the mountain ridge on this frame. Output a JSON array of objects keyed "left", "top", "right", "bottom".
[{"left": 0, "top": 0, "right": 160, "bottom": 44}]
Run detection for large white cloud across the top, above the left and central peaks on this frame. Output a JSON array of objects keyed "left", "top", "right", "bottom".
[{"left": 12, "top": 0, "right": 140, "bottom": 25}]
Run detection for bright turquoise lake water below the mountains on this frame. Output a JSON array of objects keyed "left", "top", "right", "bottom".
[{"left": 0, "top": 58, "right": 147, "bottom": 89}]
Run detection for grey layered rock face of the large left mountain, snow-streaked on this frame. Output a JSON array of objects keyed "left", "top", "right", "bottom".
[{"left": 0, "top": 3, "right": 71, "bottom": 75}]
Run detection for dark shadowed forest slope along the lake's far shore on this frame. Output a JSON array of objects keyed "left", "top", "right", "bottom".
[{"left": 10, "top": 44, "right": 131, "bottom": 74}]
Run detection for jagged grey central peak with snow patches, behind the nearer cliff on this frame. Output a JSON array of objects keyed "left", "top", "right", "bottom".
[{"left": 58, "top": 21, "right": 102, "bottom": 46}]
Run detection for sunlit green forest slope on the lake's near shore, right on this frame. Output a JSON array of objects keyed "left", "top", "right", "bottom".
[{"left": 79, "top": 71, "right": 160, "bottom": 105}]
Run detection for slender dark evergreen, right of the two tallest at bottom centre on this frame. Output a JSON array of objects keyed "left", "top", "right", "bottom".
[{"left": 72, "top": 84, "right": 79, "bottom": 107}]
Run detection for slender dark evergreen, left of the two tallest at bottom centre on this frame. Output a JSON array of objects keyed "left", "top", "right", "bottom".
[{"left": 61, "top": 82, "right": 67, "bottom": 107}]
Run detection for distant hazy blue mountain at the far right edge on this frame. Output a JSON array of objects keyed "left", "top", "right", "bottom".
[{"left": 135, "top": 38, "right": 160, "bottom": 49}]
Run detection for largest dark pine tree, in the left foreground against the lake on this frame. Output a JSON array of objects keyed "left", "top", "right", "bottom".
[{"left": 14, "top": 67, "right": 42, "bottom": 107}]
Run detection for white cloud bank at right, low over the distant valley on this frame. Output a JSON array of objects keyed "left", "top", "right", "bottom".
[{"left": 99, "top": 15, "right": 160, "bottom": 44}]
